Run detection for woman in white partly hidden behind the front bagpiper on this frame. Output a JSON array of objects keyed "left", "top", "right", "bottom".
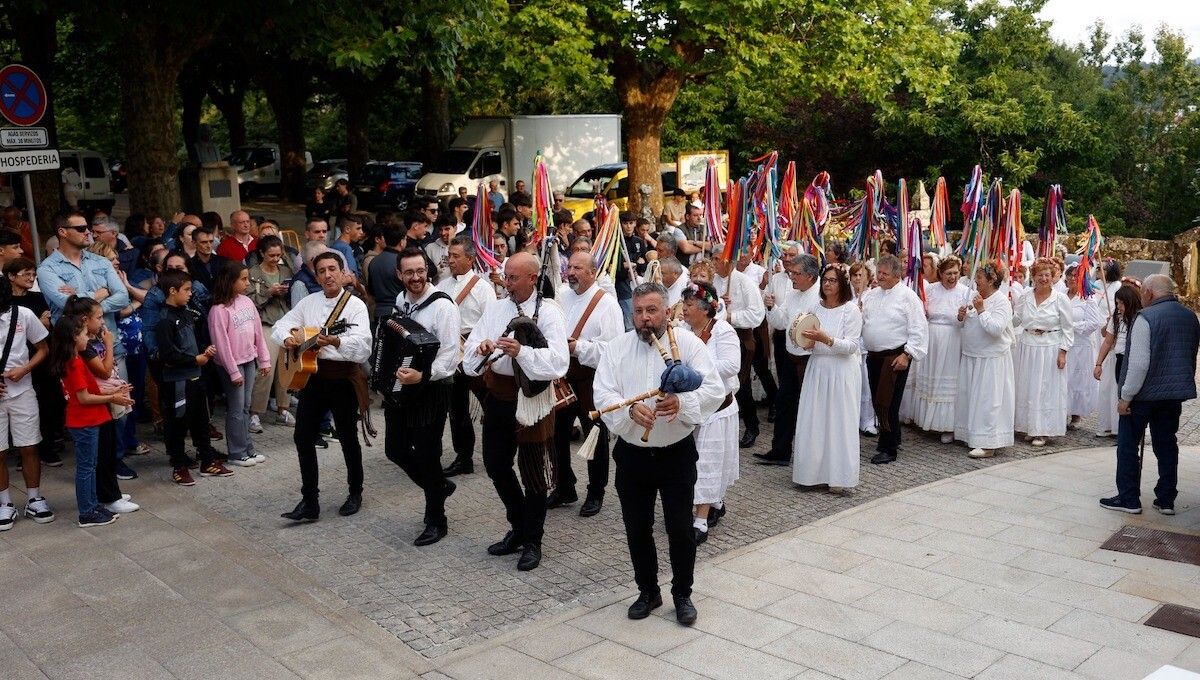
[{"left": 683, "top": 281, "right": 742, "bottom": 543}]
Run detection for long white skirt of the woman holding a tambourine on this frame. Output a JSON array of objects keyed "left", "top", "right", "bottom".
[{"left": 792, "top": 354, "right": 863, "bottom": 488}]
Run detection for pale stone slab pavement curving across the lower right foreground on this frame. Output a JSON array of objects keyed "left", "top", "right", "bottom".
[{"left": 422, "top": 447, "right": 1200, "bottom": 680}]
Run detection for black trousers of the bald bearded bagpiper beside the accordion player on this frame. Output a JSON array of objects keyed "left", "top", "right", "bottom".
[{"left": 481, "top": 393, "right": 546, "bottom": 546}]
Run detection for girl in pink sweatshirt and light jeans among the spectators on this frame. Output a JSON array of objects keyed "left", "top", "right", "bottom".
[{"left": 209, "top": 263, "right": 271, "bottom": 468}]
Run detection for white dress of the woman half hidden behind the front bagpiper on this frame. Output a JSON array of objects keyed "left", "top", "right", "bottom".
[{"left": 692, "top": 317, "right": 742, "bottom": 505}]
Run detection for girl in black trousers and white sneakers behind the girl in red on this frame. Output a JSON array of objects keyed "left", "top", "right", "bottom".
[{"left": 62, "top": 295, "right": 139, "bottom": 513}]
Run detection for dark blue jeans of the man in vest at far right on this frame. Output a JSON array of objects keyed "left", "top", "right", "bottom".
[{"left": 1117, "top": 401, "right": 1183, "bottom": 507}]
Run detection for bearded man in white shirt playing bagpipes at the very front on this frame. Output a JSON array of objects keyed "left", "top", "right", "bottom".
[{"left": 595, "top": 283, "right": 725, "bottom": 626}]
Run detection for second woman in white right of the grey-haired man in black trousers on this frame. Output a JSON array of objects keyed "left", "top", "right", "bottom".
[{"left": 954, "top": 263, "right": 1015, "bottom": 458}]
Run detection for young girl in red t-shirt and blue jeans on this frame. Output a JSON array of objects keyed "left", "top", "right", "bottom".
[{"left": 50, "top": 314, "right": 133, "bottom": 526}]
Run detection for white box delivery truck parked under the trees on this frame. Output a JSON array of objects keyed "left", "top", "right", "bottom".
[{"left": 415, "top": 114, "right": 622, "bottom": 201}]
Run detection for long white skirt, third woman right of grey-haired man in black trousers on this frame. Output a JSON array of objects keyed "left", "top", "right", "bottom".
[{"left": 1014, "top": 342, "right": 1067, "bottom": 437}]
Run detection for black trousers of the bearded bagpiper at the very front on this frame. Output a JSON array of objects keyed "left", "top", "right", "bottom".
[{"left": 612, "top": 435, "right": 698, "bottom": 597}]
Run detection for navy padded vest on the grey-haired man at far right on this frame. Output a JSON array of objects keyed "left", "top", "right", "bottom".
[{"left": 1120, "top": 297, "right": 1200, "bottom": 402}]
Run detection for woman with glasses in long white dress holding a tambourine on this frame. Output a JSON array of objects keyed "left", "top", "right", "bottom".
[{"left": 792, "top": 265, "right": 863, "bottom": 493}]
